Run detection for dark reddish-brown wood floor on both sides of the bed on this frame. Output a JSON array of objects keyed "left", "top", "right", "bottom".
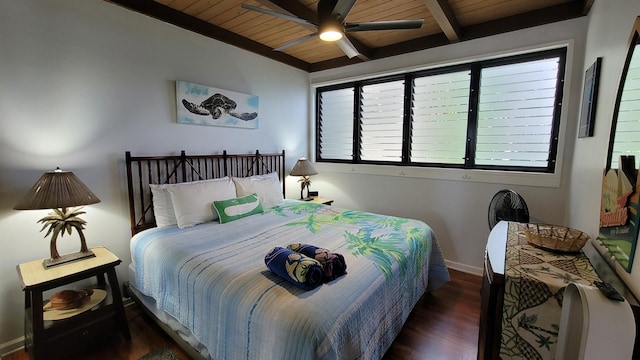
[{"left": 3, "top": 270, "right": 482, "bottom": 360}]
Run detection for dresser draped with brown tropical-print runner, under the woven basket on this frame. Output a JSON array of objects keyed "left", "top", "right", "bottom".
[{"left": 478, "top": 221, "right": 638, "bottom": 359}]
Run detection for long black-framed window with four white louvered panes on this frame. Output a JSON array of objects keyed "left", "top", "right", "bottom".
[{"left": 316, "top": 48, "right": 566, "bottom": 173}]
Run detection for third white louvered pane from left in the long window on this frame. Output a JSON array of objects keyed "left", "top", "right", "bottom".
[{"left": 411, "top": 70, "right": 471, "bottom": 164}]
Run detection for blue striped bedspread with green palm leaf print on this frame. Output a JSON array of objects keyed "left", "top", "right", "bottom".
[{"left": 131, "top": 201, "right": 449, "bottom": 359}]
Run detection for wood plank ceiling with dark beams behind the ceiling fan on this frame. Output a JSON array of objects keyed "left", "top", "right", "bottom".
[{"left": 106, "top": 0, "right": 594, "bottom": 72}]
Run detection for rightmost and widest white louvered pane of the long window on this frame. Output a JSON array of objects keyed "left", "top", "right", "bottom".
[{"left": 475, "top": 58, "right": 559, "bottom": 168}]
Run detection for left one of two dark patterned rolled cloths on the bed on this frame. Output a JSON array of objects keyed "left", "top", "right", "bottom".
[{"left": 264, "top": 247, "right": 324, "bottom": 290}]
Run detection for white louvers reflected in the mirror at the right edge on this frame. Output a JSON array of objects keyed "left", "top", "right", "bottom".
[{"left": 611, "top": 46, "right": 640, "bottom": 169}]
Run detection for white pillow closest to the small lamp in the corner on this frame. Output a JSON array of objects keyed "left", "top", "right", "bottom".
[{"left": 232, "top": 172, "right": 284, "bottom": 209}]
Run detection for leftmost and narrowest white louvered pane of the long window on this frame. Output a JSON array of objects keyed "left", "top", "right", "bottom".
[{"left": 318, "top": 87, "right": 354, "bottom": 160}]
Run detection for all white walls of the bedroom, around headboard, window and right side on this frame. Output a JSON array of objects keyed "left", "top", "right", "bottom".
[{"left": 5, "top": 0, "right": 640, "bottom": 351}]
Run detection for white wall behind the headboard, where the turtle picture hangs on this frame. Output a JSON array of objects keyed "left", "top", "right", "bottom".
[{"left": 0, "top": 0, "right": 309, "bottom": 352}]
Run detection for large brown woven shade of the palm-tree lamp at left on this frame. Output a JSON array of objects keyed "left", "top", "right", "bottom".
[{"left": 13, "top": 169, "right": 100, "bottom": 210}]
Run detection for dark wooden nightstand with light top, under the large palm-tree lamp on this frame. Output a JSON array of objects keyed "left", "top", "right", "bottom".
[{"left": 17, "top": 247, "right": 131, "bottom": 360}]
